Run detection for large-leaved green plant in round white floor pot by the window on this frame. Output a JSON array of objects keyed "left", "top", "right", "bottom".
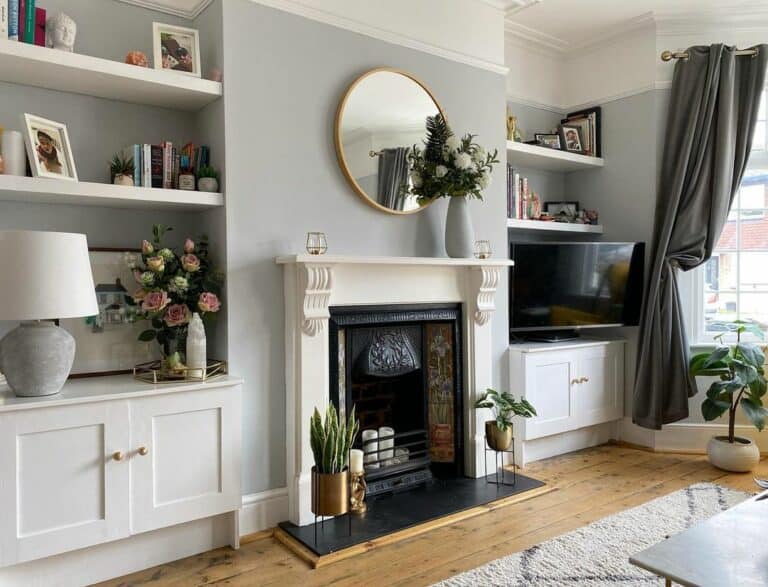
[{"left": 689, "top": 321, "right": 768, "bottom": 473}]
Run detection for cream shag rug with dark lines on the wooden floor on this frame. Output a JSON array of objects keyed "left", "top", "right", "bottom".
[{"left": 438, "top": 483, "right": 750, "bottom": 587}]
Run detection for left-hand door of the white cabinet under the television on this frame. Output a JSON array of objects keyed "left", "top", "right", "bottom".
[{"left": 523, "top": 351, "right": 576, "bottom": 440}]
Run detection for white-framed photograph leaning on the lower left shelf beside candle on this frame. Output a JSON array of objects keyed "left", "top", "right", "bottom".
[{"left": 22, "top": 114, "right": 77, "bottom": 181}]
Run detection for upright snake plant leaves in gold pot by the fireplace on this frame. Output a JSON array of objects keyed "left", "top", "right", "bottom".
[{"left": 309, "top": 403, "right": 360, "bottom": 475}]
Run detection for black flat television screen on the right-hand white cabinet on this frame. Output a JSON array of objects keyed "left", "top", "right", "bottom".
[{"left": 509, "top": 243, "right": 645, "bottom": 332}]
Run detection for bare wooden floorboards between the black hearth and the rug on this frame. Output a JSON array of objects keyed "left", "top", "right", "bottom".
[{"left": 96, "top": 445, "right": 768, "bottom": 587}]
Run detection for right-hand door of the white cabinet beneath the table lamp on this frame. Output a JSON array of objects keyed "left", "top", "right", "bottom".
[{"left": 130, "top": 387, "right": 241, "bottom": 533}]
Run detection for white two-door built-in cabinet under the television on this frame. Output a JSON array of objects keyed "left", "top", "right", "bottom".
[{"left": 509, "top": 340, "right": 624, "bottom": 441}]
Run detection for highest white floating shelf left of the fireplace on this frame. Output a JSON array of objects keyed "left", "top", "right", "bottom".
[{"left": 0, "top": 41, "right": 222, "bottom": 111}]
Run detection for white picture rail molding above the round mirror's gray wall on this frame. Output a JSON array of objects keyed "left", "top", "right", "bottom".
[{"left": 250, "top": 0, "right": 509, "bottom": 75}]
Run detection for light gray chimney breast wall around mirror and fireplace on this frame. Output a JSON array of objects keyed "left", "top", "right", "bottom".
[{"left": 224, "top": 0, "right": 507, "bottom": 493}]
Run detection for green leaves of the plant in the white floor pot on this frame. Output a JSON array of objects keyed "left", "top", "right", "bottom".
[{"left": 689, "top": 320, "right": 768, "bottom": 443}]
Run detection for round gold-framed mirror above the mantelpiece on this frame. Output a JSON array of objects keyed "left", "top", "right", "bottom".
[{"left": 335, "top": 68, "right": 445, "bottom": 214}]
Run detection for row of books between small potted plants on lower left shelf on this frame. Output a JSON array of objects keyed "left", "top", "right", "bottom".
[{"left": 123, "top": 141, "right": 211, "bottom": 190}]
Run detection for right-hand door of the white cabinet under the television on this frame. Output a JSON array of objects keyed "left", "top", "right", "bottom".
[{"left": 573, "top": 344, "right": 624, "bottom": 427}]
